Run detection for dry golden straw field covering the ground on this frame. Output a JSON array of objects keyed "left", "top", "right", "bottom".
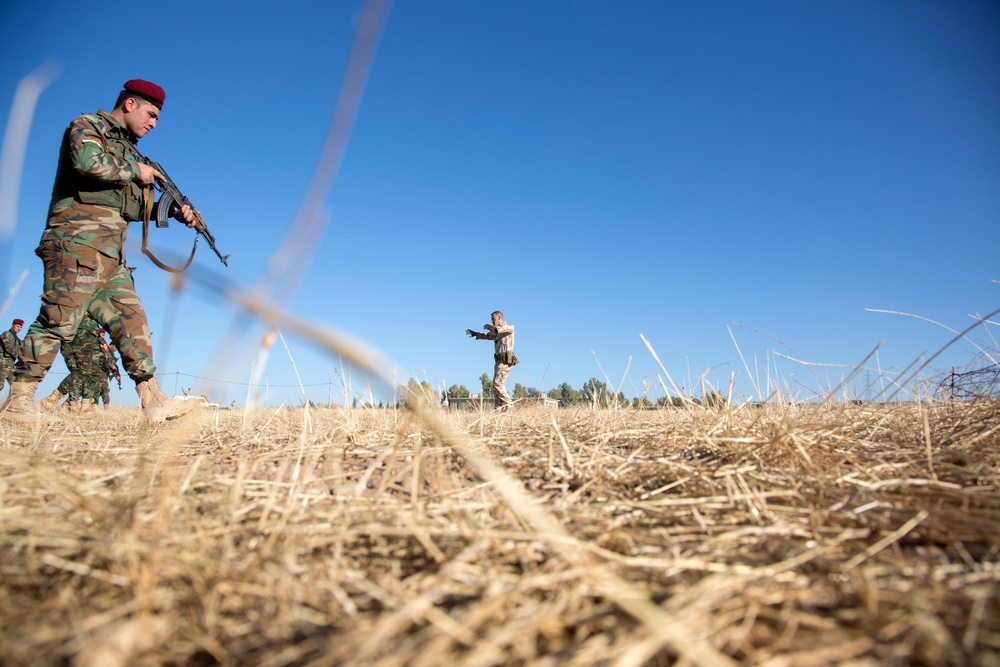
[{"left": 0, "top": 401, "right": 1000, "bottom": 667}]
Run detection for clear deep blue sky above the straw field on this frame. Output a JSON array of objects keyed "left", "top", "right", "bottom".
[{"left": 0, "top": 0, "right": 1000, "bottom": 404}]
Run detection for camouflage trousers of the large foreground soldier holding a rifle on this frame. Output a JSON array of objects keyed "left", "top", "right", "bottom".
[{"left": 15, "top": 241, "right": 156, "bottom": 382}]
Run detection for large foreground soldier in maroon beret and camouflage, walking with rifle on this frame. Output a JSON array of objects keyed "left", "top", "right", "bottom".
[{"left": 0, "top": 79, "right": 201, "bottom": 422}]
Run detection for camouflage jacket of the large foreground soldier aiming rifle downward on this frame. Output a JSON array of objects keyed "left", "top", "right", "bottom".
[{"left": 42, "top": 110, "right": 142, "bottom": 261}]
